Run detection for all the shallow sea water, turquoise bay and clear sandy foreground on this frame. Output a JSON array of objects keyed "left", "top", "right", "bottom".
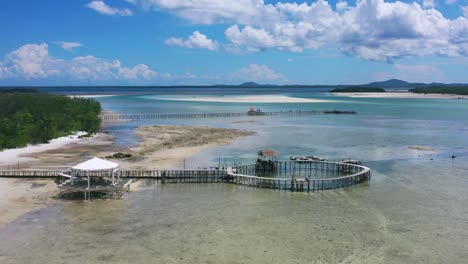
[{"left": 0, "top": 89, "right": 468, "bottom": 263}]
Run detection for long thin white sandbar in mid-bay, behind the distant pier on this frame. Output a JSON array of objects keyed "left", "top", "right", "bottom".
[{"left": 153, "top": 95, "right": 332, "bottom": 103}]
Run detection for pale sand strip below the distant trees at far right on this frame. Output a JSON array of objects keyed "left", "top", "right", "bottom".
[{"left": 331, "top": 91, "right": 468, "bottom": 99}]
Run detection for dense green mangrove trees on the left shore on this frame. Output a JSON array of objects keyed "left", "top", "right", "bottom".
[{"left": 0, "top": 92, "right": 101, "bottom": 149}]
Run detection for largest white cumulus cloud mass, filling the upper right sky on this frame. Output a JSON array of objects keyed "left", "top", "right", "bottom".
[{"left": 126, "top": 0, "right": 468, "bottom": 62}]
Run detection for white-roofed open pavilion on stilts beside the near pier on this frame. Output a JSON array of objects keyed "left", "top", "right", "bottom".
[{"left": 58, "top": 157, "right": 131, "bottom": 200}]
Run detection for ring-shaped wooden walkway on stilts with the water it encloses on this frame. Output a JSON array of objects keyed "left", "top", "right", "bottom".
[{"left": 227, "top": 161, "right": 371, "bottom": 191}]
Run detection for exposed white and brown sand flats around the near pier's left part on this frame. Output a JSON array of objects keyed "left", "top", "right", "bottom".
[{"left": 0, "top": 126, "right": 255, "bottom": 226}]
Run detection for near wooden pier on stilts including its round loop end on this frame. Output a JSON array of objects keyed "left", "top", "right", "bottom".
[{"left": 0, "top": 161, "right": 371, "bottom": 192}]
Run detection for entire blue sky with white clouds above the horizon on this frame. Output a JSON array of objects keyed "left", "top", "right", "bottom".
[{"left": 0, "top": 0, "right": 468, "bottom": 85}]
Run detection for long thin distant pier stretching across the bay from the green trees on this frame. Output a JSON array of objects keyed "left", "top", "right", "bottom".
[{"left": 99, "top": 110, "right": 356, "bottom": 120}]
